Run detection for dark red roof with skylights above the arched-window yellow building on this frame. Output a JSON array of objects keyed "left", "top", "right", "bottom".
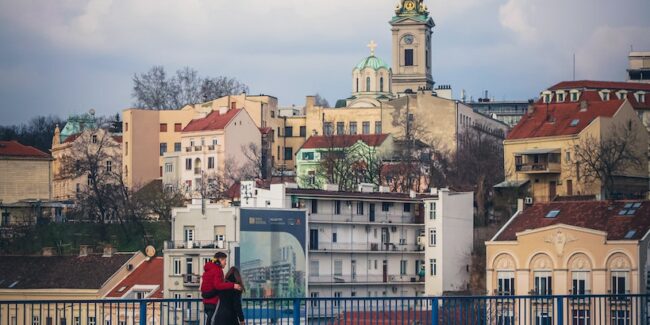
[{"left": 496, "top": 201, "right": 650, "bottom": 241}]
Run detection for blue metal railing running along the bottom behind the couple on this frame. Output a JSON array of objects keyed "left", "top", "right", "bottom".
[{"left": 0, "top": 295, "right": 650, "bottom": 325}]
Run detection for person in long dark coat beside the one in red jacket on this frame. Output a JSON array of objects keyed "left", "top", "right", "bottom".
[{"left": 214, "top": 266, "right": 245, "bottom": 325}]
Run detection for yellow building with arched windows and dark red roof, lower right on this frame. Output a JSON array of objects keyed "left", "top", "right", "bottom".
[{"left": 485, "top": 201, "right": 650, "bottom": 324}]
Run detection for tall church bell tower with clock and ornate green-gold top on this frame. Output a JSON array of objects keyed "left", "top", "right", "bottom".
[{"left": 390, "top": 0, "right": 435, "bottom": 94}]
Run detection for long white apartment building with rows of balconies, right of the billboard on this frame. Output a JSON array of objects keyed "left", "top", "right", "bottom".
[{"left": 241, "top": 182, "right": 473, "bottom": 297}]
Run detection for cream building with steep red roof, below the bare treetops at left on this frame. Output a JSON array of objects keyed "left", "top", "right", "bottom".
[{"left": 160, "top": 107, "right": 262, "bottom": 198}]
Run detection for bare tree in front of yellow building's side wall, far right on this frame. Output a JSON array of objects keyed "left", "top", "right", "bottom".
[{"left": 575, "top": 121, "right": 646, "bottom": 199}]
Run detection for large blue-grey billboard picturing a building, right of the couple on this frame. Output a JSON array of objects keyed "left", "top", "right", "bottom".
[{"left": 237, "top": 209, "right": 307, "bottom": 298}]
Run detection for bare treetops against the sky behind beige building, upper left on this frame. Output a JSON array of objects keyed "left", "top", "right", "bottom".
[{"left": 131, "top": 66, "right": 248, "bottom": 110}]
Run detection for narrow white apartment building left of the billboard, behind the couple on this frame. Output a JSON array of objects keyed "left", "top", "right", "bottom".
[{"left": 163, "top": 200, "right": 239, "bottom": 298}]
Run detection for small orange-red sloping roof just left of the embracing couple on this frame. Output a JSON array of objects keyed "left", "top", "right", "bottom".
[{"left": 106, "top": 257, "right": 164, "bottom": 299}]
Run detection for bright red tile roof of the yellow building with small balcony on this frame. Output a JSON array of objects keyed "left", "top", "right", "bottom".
[{"left": 507, "top": 92, "right": 623, "bottom": 140}]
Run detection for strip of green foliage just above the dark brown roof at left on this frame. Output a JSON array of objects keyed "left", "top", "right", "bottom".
[{"left": 0, "top": 222, "right": 171, "bottom": 255}]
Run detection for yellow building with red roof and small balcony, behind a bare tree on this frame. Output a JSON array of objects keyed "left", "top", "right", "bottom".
[{"left": 504, "top": 89, "right": 648, "bottom": 202}]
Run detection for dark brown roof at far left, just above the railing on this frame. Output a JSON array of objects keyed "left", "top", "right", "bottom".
[{"left": 0, "top": 253, "right": 134, "bottom": 289}]
